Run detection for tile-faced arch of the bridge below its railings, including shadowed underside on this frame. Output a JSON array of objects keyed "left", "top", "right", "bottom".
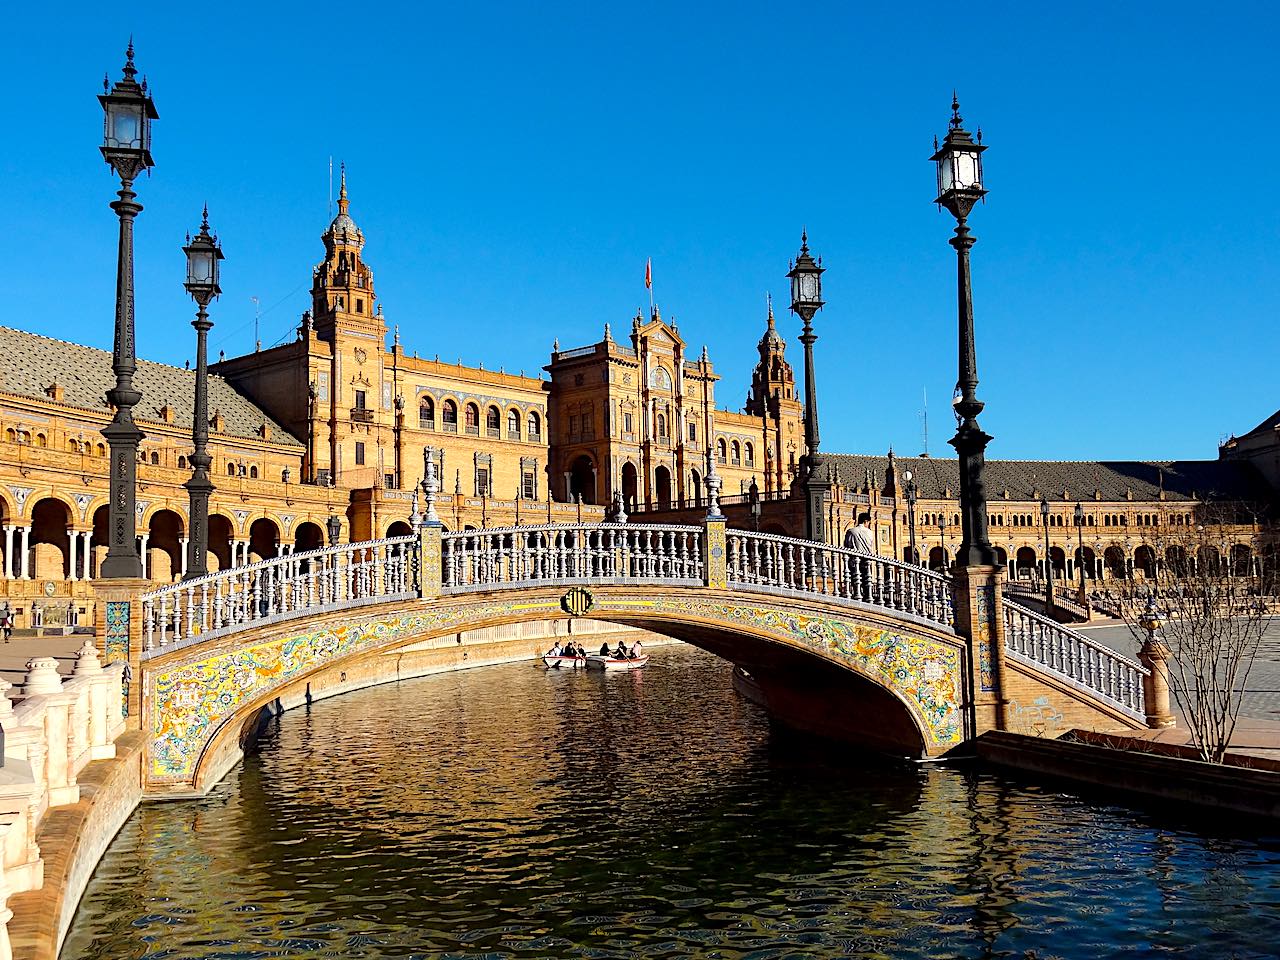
[{"left": 141, "top": 586, "right": 970, "bottom": 796}]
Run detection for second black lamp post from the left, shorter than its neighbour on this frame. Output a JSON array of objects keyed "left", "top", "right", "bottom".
[{"left": 182, "top": 206, "right": 222, "bottom": 580}]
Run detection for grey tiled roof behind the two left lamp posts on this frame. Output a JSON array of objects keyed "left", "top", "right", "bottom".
[{"left": 0, "top": 326, "right": 301, "bottom": 447}]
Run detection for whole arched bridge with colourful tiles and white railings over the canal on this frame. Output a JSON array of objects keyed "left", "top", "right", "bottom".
[{"left": 104, "top": 518, "right": 1147, "bottom": 794}]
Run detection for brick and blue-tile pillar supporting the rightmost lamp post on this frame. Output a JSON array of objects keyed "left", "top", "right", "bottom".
[{"left": 951, "top": 566, "right": 1007, "bottom": 736}]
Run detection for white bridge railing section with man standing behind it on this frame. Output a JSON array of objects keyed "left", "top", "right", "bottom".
[{"left": 727, "top": 530, "right": 954, "bottom": 628}]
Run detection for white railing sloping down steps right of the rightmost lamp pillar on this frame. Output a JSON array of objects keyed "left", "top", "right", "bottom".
[{"left": 1005, "top": 598, "right": 1148, "bottom": 719}]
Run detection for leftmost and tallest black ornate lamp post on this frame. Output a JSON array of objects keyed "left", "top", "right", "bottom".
[{"left": 99, "top": 41, "right": 159, "bottom": 580}]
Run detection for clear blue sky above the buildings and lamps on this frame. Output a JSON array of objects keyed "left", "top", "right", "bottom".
[{"left": 0, "top": 3, "right": 1280, "bottom": 460}]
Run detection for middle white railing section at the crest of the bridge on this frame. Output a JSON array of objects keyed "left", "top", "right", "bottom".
[{"left": 440, "top": 524, "right": 705, "bottom": 594}]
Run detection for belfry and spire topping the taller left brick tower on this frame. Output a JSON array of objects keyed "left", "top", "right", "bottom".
[{"left": 311, "top": 164, "right": 387, "bottom": 343}]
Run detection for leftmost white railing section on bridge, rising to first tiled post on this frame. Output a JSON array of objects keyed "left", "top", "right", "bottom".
[{"left": 140, "top": 536, "right": 417, "bottom": 650}]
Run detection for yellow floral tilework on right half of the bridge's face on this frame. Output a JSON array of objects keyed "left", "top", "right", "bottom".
[{"left": 606, "top": 598, "right": 964, "bottom": 746}]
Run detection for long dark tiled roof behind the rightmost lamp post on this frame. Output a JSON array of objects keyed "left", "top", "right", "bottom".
[{"left": 823, "top": 453, "right": 1275, "bottom": 503}]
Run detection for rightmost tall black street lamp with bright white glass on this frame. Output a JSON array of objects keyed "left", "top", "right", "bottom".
[{"left": 931, "top": 96, "right": 996, "bottom": 567}]
